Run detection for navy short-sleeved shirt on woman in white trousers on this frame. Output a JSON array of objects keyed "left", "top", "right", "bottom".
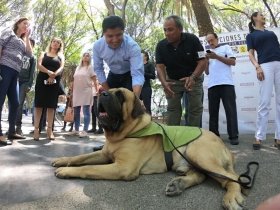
[{"left": 246, "top": 30, "right": 280, "bottom": 64}]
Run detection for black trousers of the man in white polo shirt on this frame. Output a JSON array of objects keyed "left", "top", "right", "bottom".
[{"left": 208, "top": 85, "right": 238, "bottom": 139}]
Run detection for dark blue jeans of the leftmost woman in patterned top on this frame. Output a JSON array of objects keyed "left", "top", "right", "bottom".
[{"left": 0, "top": 65, "right": 19, "bottom": 136}]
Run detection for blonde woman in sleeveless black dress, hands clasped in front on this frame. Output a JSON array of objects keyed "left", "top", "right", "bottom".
[{"left": 34, "top": 38, "right": 64, "bottom": 141}]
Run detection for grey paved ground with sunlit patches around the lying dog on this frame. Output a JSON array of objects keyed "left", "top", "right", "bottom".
[{"left": 0, "top": 114, "right": 280, "bottom": 210}]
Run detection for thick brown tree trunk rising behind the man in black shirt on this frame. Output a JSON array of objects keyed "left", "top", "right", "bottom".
[{"left": 190, "top": 0, "right": 214, "bottom": 36}]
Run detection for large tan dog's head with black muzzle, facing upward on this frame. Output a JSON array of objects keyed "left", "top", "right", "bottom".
[{"left": 98, "top": 88, "right": 150, "bottom": 139}]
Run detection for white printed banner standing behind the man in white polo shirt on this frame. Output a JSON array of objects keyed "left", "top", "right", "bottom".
[{"left": 199, "top": 28, "right": 280, "bottom": 134}]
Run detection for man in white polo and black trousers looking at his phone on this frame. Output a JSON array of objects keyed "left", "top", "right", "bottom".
[{"left": 205, "top": 33, "right": 239, "bottom": 145}]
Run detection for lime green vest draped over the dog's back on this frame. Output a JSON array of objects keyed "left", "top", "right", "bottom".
[{"left": 127, "top": 121, "right": 201, "bottom": 152}]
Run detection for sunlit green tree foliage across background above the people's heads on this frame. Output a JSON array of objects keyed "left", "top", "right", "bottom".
[{"left": 0, "top": 0, "right": 280, "bottom": 113}]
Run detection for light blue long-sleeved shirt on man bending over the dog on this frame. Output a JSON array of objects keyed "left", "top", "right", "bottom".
[{"left": 93, "top": 35, "right": 144, "bottom": 86}]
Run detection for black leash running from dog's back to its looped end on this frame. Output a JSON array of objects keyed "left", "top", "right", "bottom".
[{"left": 156, "top": 122, "right": 259, "bottom": 189}]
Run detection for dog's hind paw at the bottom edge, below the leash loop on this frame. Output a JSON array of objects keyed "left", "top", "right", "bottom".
[{"left": 222, "top": 193, "right": 244, "bottom": 210}]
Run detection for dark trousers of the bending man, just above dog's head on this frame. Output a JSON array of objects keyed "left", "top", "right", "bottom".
[{"left": 107, "top": 71, "right": 132, "bottom": 91}]
